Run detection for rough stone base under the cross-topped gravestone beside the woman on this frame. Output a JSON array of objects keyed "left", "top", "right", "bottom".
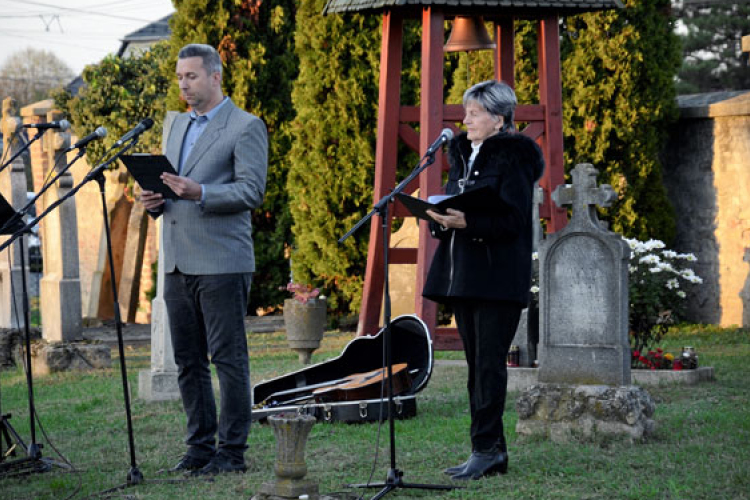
[{"left": 516, "top": 384, "right": 656, "bottom": 442}]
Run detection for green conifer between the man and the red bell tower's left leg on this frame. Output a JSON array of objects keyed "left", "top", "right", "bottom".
[{"left": 288, "top": 0, "right": 380, "bottom": 313}]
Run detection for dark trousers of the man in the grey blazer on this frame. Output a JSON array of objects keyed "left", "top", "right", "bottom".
[{"left": 164, "top": 271, "right": 252, "bottom": 459}]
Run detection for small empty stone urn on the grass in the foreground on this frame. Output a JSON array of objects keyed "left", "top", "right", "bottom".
[{"left": 258, "top": 413, "right": 318, "bottom": 500}]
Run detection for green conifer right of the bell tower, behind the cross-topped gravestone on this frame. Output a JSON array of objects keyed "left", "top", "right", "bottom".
[{"left": 561, "top": 0, "right": 680, "bottom": 242}]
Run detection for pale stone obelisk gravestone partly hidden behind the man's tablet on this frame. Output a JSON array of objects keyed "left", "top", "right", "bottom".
[{"left": 138, "top": 111, "right": 180, "bottom": 401}]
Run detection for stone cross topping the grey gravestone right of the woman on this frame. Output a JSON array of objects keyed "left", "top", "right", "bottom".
[{"left": 552, "top": 163, "right": 617, "bottom": 229}]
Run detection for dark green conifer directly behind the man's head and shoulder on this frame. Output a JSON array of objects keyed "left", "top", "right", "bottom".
[{"left": 165, "top": 0, "right": 297, "bottom": 311}]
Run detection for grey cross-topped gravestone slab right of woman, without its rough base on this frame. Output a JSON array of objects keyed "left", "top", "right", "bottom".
[{"left": 539, "top": 164, "right": 630, "bottom": 386}]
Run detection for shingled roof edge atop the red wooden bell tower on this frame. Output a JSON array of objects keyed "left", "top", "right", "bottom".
[{"left": 323, "top": 0, "right": 623, "bottom": 15}]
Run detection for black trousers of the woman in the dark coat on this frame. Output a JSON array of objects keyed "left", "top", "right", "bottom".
[{"left": 451, "top": 300, "right": 522, "bottom": 451}]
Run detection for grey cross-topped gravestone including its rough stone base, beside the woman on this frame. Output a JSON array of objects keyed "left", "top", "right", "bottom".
[{"left": 516, "top": 164, "right": 654, "bottom": 440}]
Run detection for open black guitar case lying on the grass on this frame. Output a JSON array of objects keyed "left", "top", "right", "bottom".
[{"left": 252, "top": 315, "right": 433, "bottom": 423}]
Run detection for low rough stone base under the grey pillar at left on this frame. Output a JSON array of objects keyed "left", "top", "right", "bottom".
[{"left": 31, "top": 342, "right": 112, "bottom": 375}]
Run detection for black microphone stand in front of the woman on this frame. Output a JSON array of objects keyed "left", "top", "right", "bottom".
[{"left": 338, "top": 152, "right": 462, "bottom": 500}]
